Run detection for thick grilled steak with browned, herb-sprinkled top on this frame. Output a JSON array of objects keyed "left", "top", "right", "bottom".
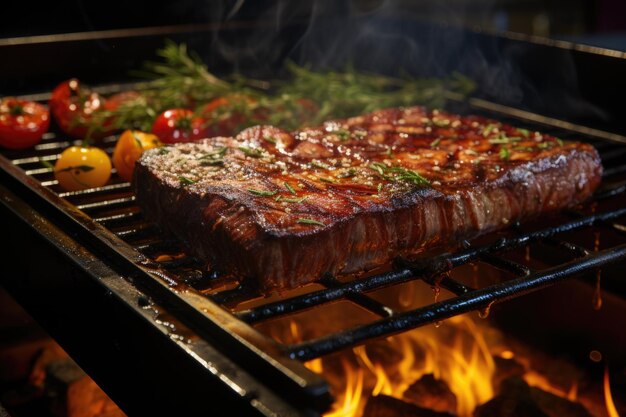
[{"left": 134, "top": 107, "right": 602, "bottom": 292}]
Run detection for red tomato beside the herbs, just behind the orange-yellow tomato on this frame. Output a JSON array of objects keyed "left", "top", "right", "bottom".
[{"left": 152, "top": 109, "right": 206, "bottom": 143}]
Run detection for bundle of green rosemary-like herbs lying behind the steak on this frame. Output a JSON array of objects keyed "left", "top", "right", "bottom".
[{"left": 87, "top": 41, "right": 473, "bottom": 135}]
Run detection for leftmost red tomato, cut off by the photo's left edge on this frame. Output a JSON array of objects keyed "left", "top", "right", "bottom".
[{"left": 0, "top": 97, "right": 50, "bottom": 149}]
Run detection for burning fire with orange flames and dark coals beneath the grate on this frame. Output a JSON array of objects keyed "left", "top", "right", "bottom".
[{"left": 262, "top": 278, "right": 619, "bottom": 417}]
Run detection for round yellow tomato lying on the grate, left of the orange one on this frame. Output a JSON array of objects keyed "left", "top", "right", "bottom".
[{"left": 54, "top": 146, "right": 111, "bottom": 191}]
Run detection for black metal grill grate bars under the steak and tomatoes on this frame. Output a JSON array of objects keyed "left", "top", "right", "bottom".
[{"left": 6, "top": 100, "right": 626, "bottom": 368}]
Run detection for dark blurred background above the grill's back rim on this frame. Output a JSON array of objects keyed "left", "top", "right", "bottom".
[{"left": 0, "top": 0, "right": 626, "bottom": 51}]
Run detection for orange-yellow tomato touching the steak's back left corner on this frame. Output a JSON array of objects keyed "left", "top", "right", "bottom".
[{"left": 113, "top": 130, "right": 163, "bottom": 181}]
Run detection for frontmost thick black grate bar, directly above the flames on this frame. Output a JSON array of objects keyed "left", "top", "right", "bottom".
[{"left": 286, "top": 244, "right": 626, "bottom": 361}]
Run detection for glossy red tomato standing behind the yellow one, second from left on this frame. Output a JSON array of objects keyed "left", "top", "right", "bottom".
[{"left": 50, "top": 78, "right": 111, "bottom": 139}]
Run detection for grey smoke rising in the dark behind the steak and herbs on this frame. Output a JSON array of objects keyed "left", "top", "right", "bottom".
[{"left": 196, "top": 0, "right": 607, "bottom": 120}]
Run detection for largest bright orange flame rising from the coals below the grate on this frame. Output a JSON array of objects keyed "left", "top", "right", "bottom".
[{"left": 312, "top": 316, "right": 495, "bottom": 417}]
